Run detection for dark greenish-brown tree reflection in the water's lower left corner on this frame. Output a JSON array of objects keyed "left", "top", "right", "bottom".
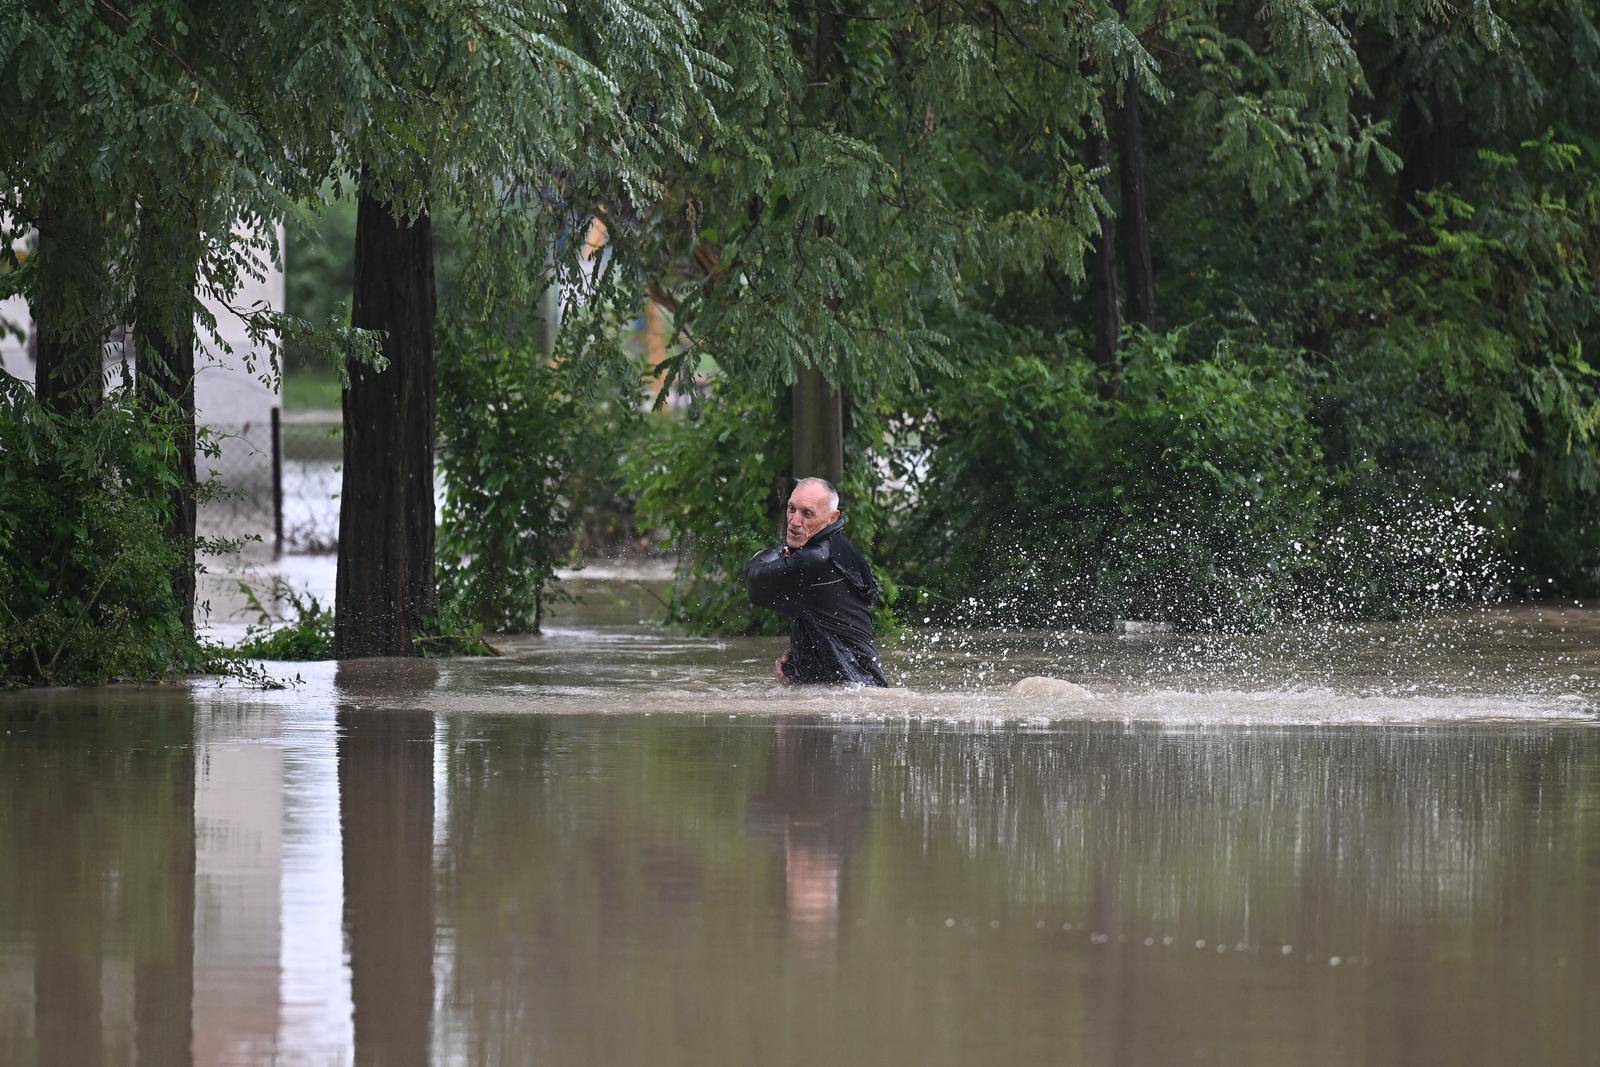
[{"left": 0, "top": 691, "right": 195, "bottom": 1067}]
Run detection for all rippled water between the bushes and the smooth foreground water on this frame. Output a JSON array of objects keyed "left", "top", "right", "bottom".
[{"left": 197, "top": 563, "right": 1600, "bottom": 726}]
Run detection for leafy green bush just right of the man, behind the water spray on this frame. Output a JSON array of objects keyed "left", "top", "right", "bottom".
[{"left": 891, "top": 333, "right": 1318, "bottom": 627}]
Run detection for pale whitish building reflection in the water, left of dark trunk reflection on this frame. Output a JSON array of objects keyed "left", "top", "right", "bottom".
[{"left": 194, "top": 684, "right": 350, "bottom": 1065}]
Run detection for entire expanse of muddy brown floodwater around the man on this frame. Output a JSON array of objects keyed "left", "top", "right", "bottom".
[{"left": 0, "top": 581, "right": 1600, "bottom": 1067}]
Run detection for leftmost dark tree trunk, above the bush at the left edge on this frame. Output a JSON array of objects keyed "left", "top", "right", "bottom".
[{"left": 30, "top": 189, "right": 112, "bottom": 414}]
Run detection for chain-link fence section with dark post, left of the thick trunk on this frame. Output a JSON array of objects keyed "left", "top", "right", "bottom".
[{"left": 195, "top": 411, "right": 344, "bottom": 552}]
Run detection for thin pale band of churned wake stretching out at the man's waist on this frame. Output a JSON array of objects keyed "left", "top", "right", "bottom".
[{"left": 302, "top": 632, "right": 1600, "bottom": 726}]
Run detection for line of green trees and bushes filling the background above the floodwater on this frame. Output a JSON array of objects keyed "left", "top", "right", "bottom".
[{"left": 0, "top": 0, "right": 1600, "bottom": 681}]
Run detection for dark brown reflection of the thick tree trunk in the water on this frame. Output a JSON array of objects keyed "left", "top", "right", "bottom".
[{"left": 338, "top": 664, "right": 434, "bottom": 1067}]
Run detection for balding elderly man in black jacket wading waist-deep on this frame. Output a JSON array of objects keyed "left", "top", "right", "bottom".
[{"left": 744, "top": 478, "right": 888, "bottom": 686}]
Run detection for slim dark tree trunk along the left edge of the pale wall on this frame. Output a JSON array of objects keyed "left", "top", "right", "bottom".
[{"left": 134, "top": 213, "right": 200, "bottom": 635}]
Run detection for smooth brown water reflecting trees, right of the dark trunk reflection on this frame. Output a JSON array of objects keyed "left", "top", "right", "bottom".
[{"left": 409, "top": 715, "right": 1600, "bottom": 1064}]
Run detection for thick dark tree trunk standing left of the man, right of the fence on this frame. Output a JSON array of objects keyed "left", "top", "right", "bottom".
[{"left": 333, "top": 192, "right": 435, "bottom": 659}]
